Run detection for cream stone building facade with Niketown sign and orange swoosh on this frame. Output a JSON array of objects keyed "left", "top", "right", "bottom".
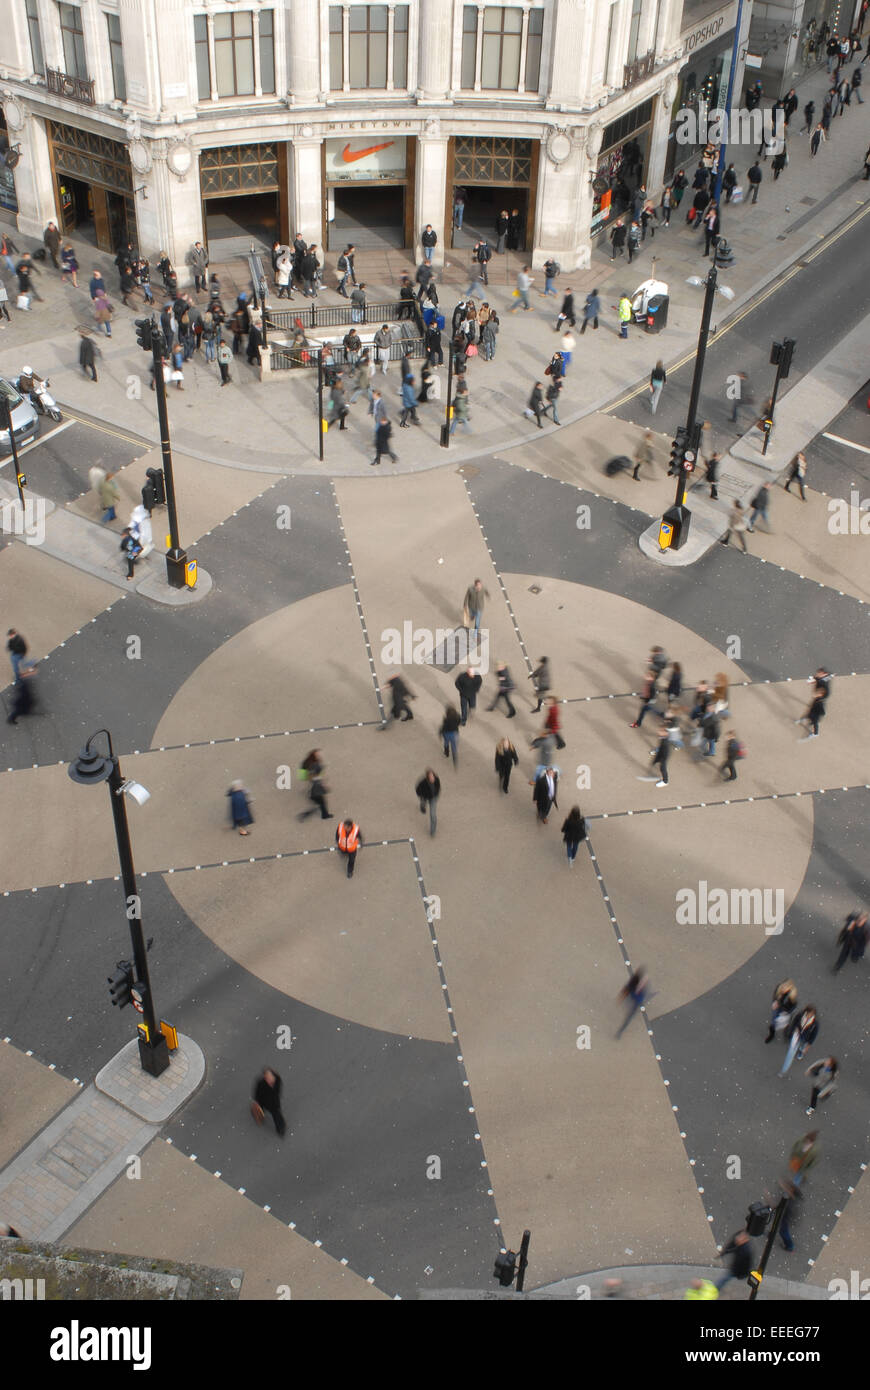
[{"left": 0, "top": 0, "right": 684, "bottom": 270}]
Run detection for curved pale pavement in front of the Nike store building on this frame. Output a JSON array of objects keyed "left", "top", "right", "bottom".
[{"left": 0, "top": 58, "right": 870, "bottom": 475}]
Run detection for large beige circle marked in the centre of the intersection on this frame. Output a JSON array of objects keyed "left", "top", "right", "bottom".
[{"left": 154, "top": 575, "right": 813, "bottom": 1045}]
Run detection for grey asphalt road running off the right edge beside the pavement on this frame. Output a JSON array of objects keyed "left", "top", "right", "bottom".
[{"left": 613, "top": 201, "right": 870, "bottom": 436}]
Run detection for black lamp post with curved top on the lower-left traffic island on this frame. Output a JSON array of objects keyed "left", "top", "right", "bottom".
[{"left": 68, "top": 728, "right": 170, "bottom": 1076}]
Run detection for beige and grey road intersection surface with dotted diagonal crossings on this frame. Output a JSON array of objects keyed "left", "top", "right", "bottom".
[{"left": 0, "top": 51, "right": 870, "bottom": 1298}]
